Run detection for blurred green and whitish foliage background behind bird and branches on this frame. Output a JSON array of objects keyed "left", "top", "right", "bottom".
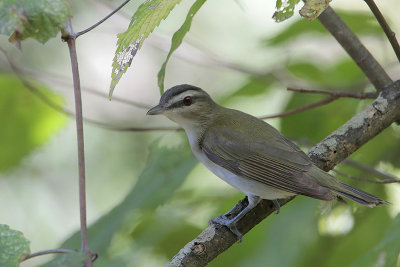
[{"left": 0, "top": 0, "right": 400, "bottom": 267}]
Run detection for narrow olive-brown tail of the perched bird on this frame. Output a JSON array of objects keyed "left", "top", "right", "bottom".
[{"left": 329, "top": 182, "right": 390, "bottom": 208}]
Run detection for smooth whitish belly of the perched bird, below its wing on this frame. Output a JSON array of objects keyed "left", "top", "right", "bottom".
[{"left": 193, "top": 146, "right": 293, "bottom": 199}]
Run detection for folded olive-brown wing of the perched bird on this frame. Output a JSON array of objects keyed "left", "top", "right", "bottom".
[{"left": 200, "top": 127, "right": 332, "bottom": 200}]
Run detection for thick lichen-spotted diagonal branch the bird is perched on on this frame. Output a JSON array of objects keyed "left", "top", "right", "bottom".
[{"left": 167, "top": 81, "right": 400, "bottom": 267}]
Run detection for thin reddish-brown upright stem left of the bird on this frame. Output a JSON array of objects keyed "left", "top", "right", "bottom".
[{"left": 62, "top": 19, "right": 92, "bottom": 267}]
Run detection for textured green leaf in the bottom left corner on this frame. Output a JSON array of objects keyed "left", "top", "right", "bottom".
[{"left": 0, "top": 224, "right": 30, "bottom": 267}]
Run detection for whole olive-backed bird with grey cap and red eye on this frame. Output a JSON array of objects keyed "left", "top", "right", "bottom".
[{"left": 147, "top": 84, "right": 387, "bottom": 238}]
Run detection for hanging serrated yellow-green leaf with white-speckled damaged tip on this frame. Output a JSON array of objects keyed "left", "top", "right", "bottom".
[{"left": 110, "top": 0, "right": 181, "bottom": 98}]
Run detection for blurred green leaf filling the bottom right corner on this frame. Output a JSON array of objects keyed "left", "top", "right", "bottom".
[{"left": 351, "top": 215, "right": 400, "bottom": 267}]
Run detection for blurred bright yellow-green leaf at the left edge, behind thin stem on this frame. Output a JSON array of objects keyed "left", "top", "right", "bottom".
[{"left": 0, "top": 74, "right": 65, "bottom": 171}]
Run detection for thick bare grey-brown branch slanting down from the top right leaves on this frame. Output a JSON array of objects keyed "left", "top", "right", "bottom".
[{"left": 318, "top": 7, "right": 392, "bottom": 92}]
